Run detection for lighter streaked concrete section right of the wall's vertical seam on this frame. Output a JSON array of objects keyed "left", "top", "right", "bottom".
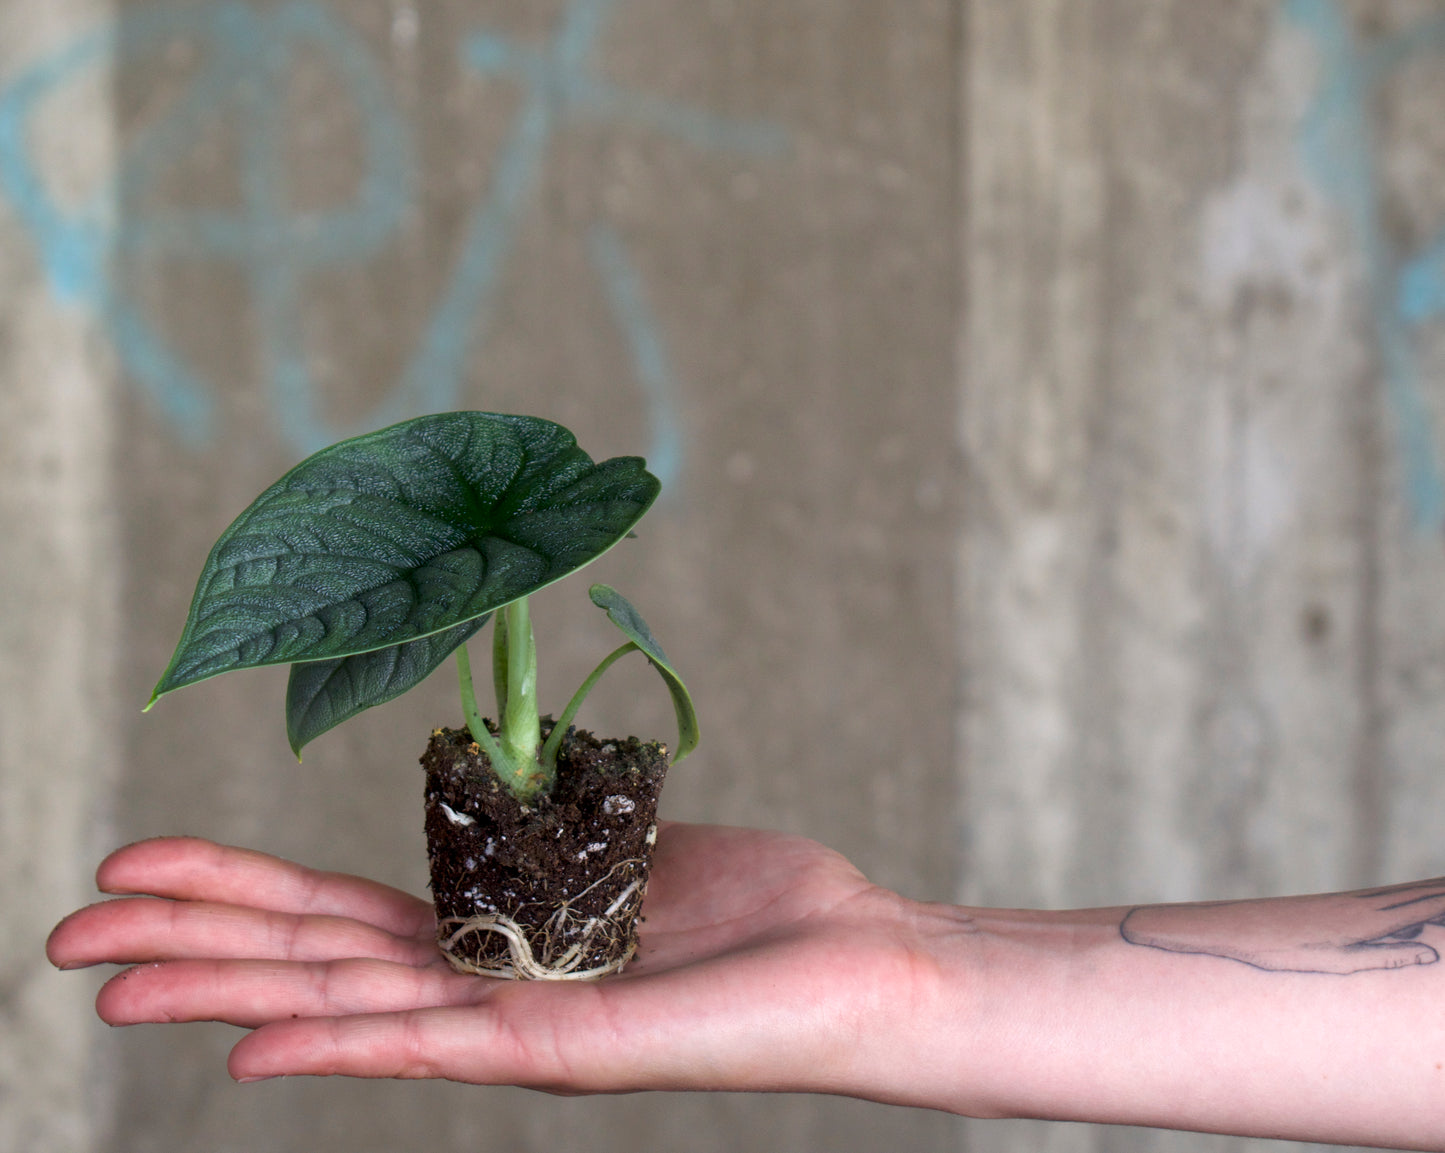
[{"left": 958, "top": 0, "right": 1445, "bottom": 1152}]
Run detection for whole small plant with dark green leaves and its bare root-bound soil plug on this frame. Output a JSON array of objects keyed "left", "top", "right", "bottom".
[{"left": 146, "top": 412, "right": 698, "bottom": 980}]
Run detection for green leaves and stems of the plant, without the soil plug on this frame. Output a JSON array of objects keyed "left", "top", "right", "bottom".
[{"left": 146, "top": 412, "right": 698, "bottom": 800}]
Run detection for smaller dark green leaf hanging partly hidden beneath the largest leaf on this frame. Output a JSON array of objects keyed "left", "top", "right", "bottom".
[{"left": 286, "top": 613, "right": 491, "bottom": 757}]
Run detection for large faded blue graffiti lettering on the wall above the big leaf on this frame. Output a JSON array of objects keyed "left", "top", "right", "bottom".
[{"left": 0, "top": 0, "right": 788, "bottom": 483}]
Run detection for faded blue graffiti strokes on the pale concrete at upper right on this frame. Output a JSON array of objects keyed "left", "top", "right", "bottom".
[{"left": 1285, "top": 0, "right": 1445, "bottom": 529}]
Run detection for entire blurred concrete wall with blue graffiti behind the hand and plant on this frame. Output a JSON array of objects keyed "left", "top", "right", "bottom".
[{"left": 0, "top": 0, "right": 1445, "bottom": 1153}]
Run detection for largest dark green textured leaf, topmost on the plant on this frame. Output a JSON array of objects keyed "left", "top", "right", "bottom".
[{"left": 152, "top": 412, "right": 659, "bottom": 704}]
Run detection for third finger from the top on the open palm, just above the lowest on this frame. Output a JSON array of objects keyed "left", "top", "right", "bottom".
[{"left": 95, "top": 958, "right": 482, "bottom": 1029}]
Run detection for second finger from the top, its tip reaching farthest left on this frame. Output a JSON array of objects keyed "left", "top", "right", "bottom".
[{"left": 46, "top": 897, "right": 435, "bottom": 968}]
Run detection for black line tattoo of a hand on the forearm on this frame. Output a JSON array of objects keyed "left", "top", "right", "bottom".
[{"left": 1118, "top": 878, "right": 1445, "bottom": 975}]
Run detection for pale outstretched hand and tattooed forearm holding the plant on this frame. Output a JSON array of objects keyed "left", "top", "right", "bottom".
[{"left": 48, "top": 824, "right": 1445, "bottom": 1149}]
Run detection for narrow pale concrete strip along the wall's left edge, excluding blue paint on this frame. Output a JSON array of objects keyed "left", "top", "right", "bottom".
[{"left": 0, "top": 0, "right": 120, "bottom": 1153}]
